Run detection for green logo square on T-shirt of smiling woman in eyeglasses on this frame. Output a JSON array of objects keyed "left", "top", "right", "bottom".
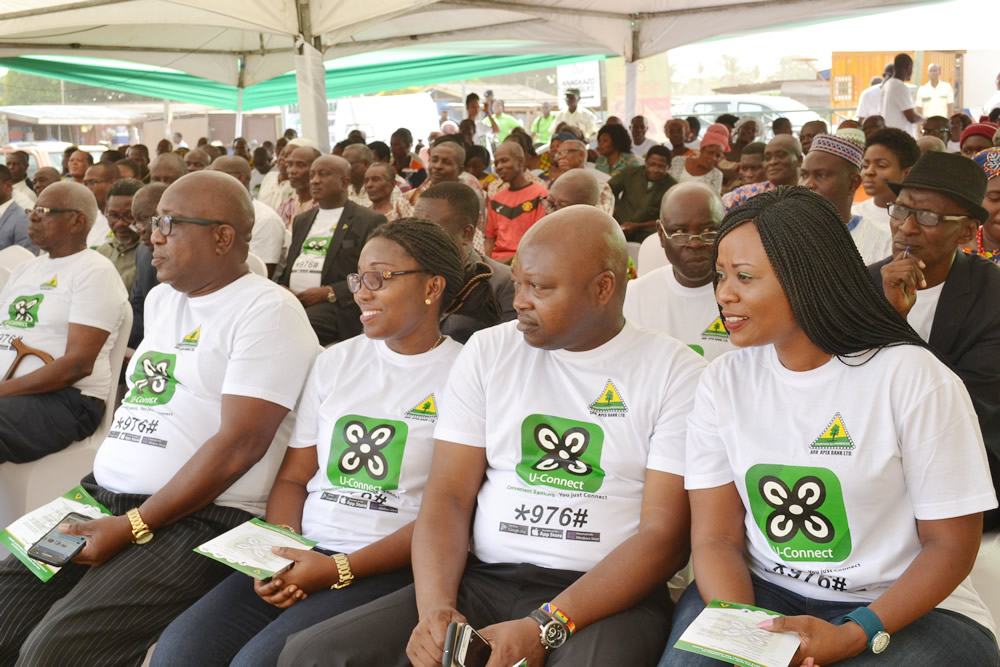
[{"left": 326, "top": 415, "right": 409, "bottom": 491}]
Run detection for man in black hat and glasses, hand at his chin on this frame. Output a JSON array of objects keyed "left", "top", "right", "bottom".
[{"left": 868, "top": 152, "right": 1000, "bottom": 529}]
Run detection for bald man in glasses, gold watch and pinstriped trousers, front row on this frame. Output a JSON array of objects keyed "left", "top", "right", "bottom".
[{"left": 0, "top": 171, "right": 318, "bottom": 665}]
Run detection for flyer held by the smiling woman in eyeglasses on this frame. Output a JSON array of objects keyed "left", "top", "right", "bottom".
[{"left": 195, "top": 519, "right": 316, "bottom": 579}]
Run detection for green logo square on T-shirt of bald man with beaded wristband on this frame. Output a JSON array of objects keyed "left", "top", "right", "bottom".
[{"left": 516, "top": 415, "right": 604, "bottom": 493}]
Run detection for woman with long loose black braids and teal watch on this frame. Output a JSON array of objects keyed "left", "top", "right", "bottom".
[{"left": 660, "top": 186, "right": 1000, "bottom": 667}]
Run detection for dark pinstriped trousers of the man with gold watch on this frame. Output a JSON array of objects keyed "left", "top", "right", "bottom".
[{"left": 0, "top": 474, "right": 251, "bottom": 667}]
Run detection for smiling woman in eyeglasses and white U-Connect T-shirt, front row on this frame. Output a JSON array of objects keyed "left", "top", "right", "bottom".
[{"left": 152, "top": 218, "right": 500, "bottom": 665}]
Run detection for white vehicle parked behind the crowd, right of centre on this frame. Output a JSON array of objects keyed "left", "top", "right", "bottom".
[{"left": 670, "top": 95, "right": 823, "bottom": 138}]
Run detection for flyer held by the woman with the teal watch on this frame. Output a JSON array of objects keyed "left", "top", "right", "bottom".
[{"left": 674, "top": 600, "right": 799, "bottom": 667}]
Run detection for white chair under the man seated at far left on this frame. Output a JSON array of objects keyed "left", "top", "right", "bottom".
[{"left": 0, "top": 304, "right": 132, "bottom": 559}]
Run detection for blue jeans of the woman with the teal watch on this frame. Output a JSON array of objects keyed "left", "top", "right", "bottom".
[{"left": 659, "top": 577, "right": 1000, "bottom": 667}]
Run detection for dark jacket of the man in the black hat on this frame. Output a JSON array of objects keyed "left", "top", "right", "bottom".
[{"left": 868, "top": 251, "right": 1000, "bottom": 528}]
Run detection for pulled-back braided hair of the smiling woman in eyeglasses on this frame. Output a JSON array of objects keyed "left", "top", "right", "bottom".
[{"left": 371, "top": 218, "right": 500, "bottom": 326}]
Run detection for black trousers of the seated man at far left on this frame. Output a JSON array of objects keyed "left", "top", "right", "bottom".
[{"left": 0, "top": 387, "right": 104, "bottom": 463}]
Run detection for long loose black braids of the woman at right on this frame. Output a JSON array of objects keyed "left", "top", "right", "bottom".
[{"left": 712, "top": 186, "right": 937, "bottom": 363}]
